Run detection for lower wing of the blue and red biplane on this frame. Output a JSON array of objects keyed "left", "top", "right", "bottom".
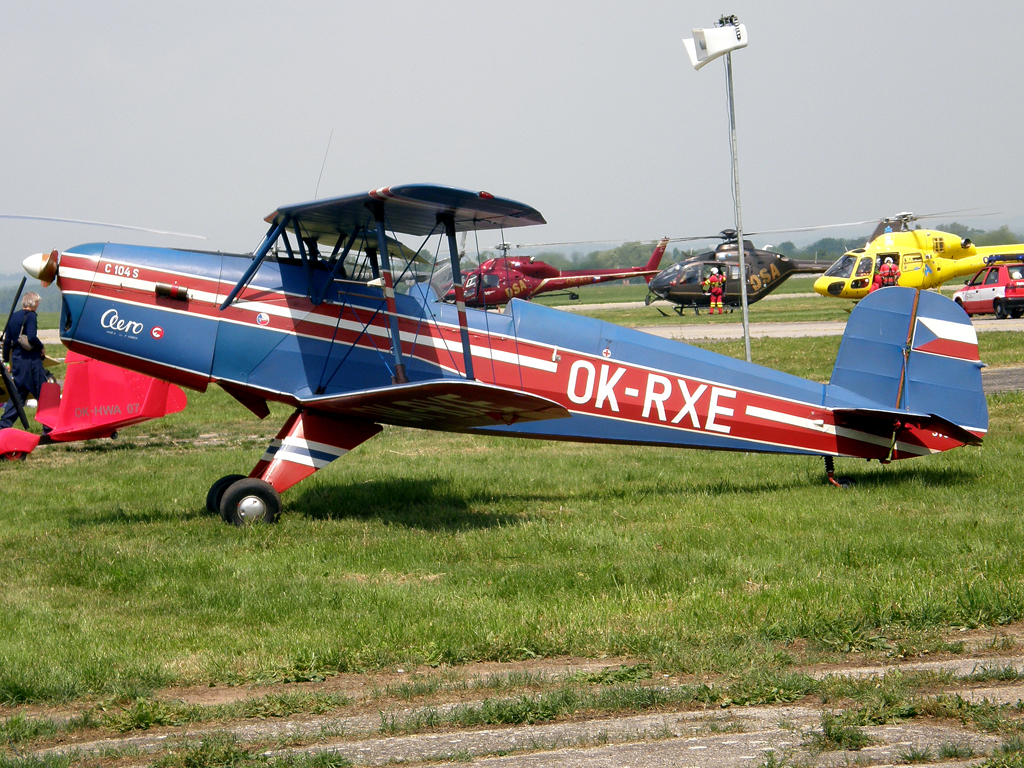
[{"left": 302, "top": 379, "right": 569, "bottom": 432}]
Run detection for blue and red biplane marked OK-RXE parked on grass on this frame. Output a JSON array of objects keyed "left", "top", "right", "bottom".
[{"left": 26, "top": 184, "right": 988, "bottom": 524}]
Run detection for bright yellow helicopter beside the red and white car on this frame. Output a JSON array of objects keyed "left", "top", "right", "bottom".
[{"left": 814, "top": 213, "right": 1024, "bottom": 300}]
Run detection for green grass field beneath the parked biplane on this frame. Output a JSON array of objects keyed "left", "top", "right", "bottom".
[{"left": 0, "top": 333, "right": 1024, "bottom": 706}]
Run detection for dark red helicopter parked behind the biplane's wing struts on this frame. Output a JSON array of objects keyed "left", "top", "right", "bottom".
[{"left": 445, "top": 238, "right": 669, "bottom": 306}]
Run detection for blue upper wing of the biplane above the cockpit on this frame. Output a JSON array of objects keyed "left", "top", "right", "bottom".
[{"left": 266, "top": 184, "right": 546, "bottom": 240}]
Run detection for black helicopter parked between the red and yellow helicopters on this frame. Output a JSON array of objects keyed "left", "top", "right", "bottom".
[{"left": 644, "top": 229, "right": 828, "bottom": 315}]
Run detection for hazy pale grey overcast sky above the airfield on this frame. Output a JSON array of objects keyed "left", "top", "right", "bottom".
[{"left": 0, "top": 0, "right": 1024, "bottom": 272}]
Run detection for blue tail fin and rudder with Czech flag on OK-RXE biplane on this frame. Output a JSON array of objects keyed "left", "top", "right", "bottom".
[{"left": 829, "top": 288, "right": 988, "bottom": 436}]
